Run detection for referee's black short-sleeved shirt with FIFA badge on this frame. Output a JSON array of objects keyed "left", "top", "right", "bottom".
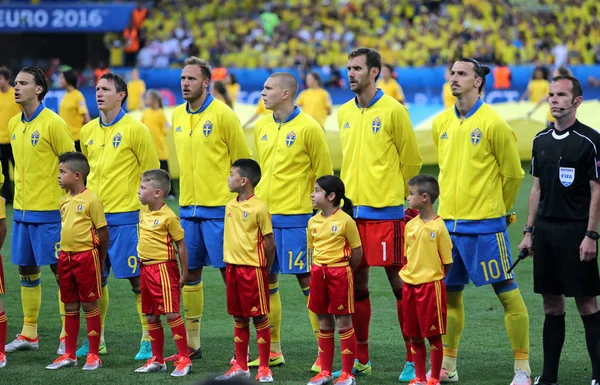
[{"left": 531, "top": 120, "right": 600, "bottom": 222}]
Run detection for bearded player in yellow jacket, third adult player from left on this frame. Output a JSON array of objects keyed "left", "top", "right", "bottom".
[{"left": 167, "top": 56, "right": 250, "bottom": 360}]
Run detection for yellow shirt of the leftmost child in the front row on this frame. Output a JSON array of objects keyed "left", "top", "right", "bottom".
[{"left": 60, "top": 189, "right": 107, "bottom": 252}]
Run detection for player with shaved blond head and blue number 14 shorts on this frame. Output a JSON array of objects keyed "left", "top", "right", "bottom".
[{"left": 250, "top": 72, "right": 333, "bottom": 372}]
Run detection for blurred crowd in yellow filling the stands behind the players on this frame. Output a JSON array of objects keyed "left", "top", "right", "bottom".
[{"left": 107, "top": 0, "right": 600, "bottom": 70}]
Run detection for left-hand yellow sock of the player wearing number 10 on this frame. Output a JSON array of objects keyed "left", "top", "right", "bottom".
[{"left": 442, "top": 291, "right": 465, "bottom": 372}]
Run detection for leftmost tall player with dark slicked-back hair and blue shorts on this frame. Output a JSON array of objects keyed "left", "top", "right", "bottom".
[{"left": 6, "top": 67, "right": 75, "bottom": 353}]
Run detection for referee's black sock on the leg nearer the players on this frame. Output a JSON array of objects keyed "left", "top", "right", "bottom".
[{"left": 540, "top": 314, "right": 564, "bottom": 383}]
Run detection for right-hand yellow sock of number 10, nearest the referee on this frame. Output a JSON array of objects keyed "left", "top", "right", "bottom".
[{"left": 498, "top": 288, "right": 531, "bottom": 373}]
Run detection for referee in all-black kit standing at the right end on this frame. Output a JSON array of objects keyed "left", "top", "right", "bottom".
[{"left": 519, "top": 76, "right": 600, "bottom": 385}]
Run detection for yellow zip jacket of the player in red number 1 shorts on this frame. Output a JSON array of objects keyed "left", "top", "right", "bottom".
[{"left": 338, "top": 90, "right": 422, "bottom": 220}]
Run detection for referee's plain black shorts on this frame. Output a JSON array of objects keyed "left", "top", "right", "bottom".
[{"left": 533, "top": 219, "right": 600, "bottom": 297}]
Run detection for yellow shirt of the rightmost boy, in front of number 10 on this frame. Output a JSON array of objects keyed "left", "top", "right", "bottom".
[{"left": 400, "top": 216, "right": 452, "bottom": 285}]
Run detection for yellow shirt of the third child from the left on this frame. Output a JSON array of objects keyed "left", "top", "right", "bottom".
[{"left": 223, "top": 195, "right": 273, "bottom": 267}]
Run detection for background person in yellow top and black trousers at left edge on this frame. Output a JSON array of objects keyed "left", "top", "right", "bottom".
[{"left": 0, "top": 67, "right": 21, "bottom": 203}]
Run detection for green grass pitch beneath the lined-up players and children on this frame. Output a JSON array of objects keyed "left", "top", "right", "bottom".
[{"left": 0, "top": 164, "right": 591, "bottom": 385}]
